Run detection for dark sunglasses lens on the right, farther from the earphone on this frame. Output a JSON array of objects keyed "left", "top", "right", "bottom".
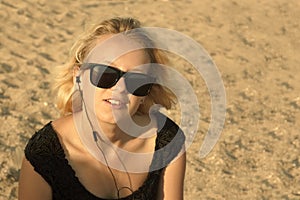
[{"left": 125, "top": 73, "right": 153, "bottom": 96}]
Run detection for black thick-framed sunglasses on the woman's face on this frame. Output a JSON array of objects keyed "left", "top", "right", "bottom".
[{"left": 80, "top": 63, "right": 155, "bottom": 96}]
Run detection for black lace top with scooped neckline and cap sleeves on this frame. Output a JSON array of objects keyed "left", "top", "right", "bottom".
[{"left": 25, "top": 115, "right": 185, "bottom": 200}]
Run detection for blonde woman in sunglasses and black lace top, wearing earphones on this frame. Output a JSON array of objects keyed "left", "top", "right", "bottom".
[{"left": 19, "top": 18, "right": 186, "bottom": 200}]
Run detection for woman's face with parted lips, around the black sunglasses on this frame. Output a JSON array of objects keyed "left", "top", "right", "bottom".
[{"left": 77, "top": 35, "right": 154, "bottom": 124}]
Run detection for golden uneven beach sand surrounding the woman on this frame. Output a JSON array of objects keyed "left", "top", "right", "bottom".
[{"left": 0, "top": 0, "right": 300, "bottom": 200}]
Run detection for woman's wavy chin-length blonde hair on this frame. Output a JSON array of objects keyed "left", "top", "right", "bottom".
[{"left": 54, "top": 18, "right": 176, "bottom": 115}]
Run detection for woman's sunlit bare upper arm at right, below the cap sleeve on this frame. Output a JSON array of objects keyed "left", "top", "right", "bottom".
[{"left": 158, "top": 153, "right": 186, "bottom": 200}]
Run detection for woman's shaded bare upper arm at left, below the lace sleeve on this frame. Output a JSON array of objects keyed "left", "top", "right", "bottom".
[{"left": 18, "top": 158, "right": 52, "bottom": 200}]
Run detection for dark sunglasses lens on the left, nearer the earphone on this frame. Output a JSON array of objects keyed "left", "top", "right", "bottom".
[{"left": 91, "top": 65, "right": 119, "bottom": 88}]
